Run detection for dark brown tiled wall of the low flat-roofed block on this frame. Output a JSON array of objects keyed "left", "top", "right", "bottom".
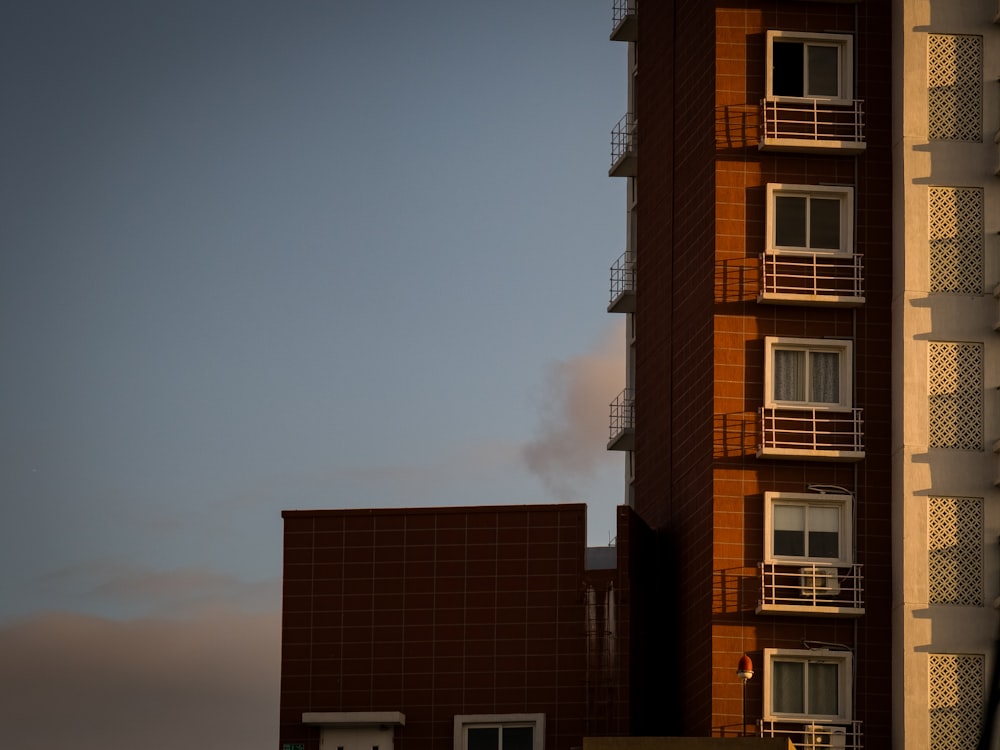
[{"left": 281, "top": 505, "right": 616, "bottom": 750}]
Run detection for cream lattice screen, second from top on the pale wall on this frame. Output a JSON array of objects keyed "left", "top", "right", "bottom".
[{"left": 927, "top": 187, "right": 985, "bottom": 294}]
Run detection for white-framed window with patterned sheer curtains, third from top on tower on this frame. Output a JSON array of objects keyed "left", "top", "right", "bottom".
[{"left": 764, "top": 336, "right": 852, "bottom": 409}]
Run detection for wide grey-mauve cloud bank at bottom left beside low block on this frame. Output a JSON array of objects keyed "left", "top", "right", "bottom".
[{"left": 0, "top": 612, "right": 280, "bottom": 750}]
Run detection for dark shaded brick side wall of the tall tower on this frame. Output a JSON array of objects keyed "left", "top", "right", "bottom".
[{"left": 635, "top": 2, "right": 715, "bottom": 735}]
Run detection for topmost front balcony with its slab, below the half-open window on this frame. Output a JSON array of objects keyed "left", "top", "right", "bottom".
[{"left": 757, "top": 99, "right": 865, "bottom": 155}]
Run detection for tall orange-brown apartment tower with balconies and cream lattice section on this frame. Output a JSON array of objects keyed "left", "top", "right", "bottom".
[{"left": 608, "top": 0, "right": 1000, "bottom": 748}]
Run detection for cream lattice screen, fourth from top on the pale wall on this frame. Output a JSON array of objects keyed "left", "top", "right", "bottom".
[{"left": 927, "top": 497, "right": 983, "bottom": 607}]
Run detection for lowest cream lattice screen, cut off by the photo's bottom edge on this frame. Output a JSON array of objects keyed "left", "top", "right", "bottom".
[{"left": 927, "top": 654, "right": 985, "bottom": 750}]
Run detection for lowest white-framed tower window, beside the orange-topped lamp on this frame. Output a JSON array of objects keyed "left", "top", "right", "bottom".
[{"left": 764, "top": 648, "right": 852, "bottom": 722}]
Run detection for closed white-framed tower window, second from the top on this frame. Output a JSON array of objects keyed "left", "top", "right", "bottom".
[{"left": 766, "top": 184, "right": 854, "bottom": 255}]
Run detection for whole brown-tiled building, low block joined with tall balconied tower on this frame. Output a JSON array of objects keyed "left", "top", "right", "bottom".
[{"left": 279, "top": 0, "right": 1000, "bottom": 750}]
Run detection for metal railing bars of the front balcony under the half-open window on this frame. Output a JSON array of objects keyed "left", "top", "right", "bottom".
[{"left": 761, "top": 99, "right": 865, "bottom": 144}]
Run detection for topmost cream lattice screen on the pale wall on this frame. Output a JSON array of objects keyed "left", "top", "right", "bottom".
[{"left": 927, "top": 34, "right": 983, "bottom": 143}]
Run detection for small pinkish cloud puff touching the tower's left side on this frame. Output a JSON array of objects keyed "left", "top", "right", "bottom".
[{"left": 522, "top": 325, "right": 625, "bottom": 500}]
